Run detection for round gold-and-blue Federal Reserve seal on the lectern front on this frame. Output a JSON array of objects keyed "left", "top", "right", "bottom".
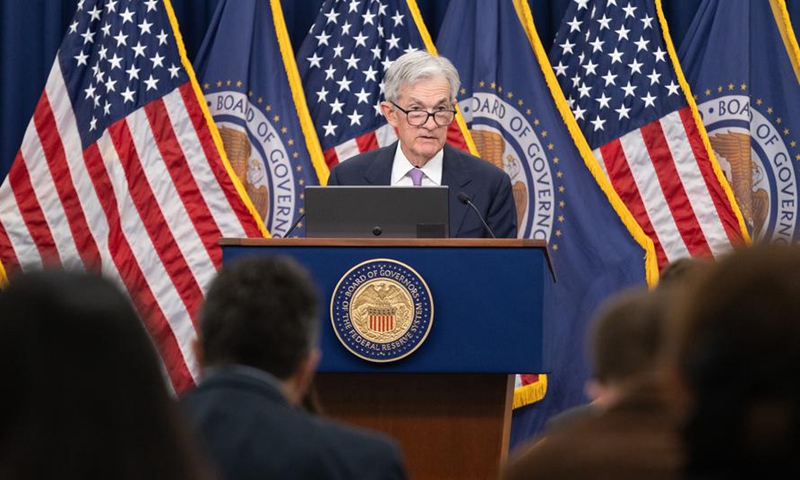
[{"left": 331, "top": 258, "right": 433, "bottom": 362}]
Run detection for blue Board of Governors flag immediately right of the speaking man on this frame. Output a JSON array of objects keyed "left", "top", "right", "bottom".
[{"left": 437, "top": 0, "right": 657, "bottom": 446}]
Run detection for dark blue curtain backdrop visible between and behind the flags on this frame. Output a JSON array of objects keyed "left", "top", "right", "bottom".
[{"left": 0, "top": 0, "right": 800, "bottom": 181}]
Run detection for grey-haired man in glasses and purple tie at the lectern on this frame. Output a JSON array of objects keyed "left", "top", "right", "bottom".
[{"left": 328, "top": 51, "right": 517, "bottom": 238}]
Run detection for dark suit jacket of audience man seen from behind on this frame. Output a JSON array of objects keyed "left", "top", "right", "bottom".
[{"left": 181, "top": 369, "right": 406, "bottom": 480}]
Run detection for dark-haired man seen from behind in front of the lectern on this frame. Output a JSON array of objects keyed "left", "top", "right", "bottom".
[{"left": 182, "top": 257, "right": 406, "bottom": 480}]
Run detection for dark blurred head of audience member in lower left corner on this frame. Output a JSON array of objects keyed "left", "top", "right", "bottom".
[{"left": 0, "top": 271, "right": 208, "bottom": 480}]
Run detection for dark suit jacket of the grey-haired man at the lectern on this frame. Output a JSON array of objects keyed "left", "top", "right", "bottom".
[{"left": 328, "top": 142, "right": 517, "bottom": 238}]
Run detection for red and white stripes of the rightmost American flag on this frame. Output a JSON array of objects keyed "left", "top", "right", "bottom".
[{"left": 594, "top": 107, "right": 742, "bottom": 266}]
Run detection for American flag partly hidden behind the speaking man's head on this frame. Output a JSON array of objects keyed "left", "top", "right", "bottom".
[{"left": 297, "top": 0, "right": 474, "bottom": 167}]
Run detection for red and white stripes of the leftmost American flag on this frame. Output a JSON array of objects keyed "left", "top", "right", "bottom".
[{"left": 0, "top": 61, "right": 261, "bottom": 392}]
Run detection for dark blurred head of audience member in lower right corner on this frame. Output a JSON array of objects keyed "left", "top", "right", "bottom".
[{"left": 674, "top": 246, "right": 800, "bottom": 479}]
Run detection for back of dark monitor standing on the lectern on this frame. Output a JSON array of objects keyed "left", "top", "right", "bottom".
[{"left": 305, "top": 186, "right": 450, "bottom": 238}]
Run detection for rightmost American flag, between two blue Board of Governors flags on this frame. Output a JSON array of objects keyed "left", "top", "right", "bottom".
[{"left": 550, "top": 0, "right": 747, "bottom": 266}]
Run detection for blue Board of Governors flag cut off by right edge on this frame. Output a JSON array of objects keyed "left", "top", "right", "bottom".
[{"left": 679, "top": 0, "right": 800, "bottom": 243}]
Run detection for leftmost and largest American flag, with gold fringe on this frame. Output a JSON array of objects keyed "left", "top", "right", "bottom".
[{"left": 0, "top": 0, "right": 264, "bottom": 392}]
